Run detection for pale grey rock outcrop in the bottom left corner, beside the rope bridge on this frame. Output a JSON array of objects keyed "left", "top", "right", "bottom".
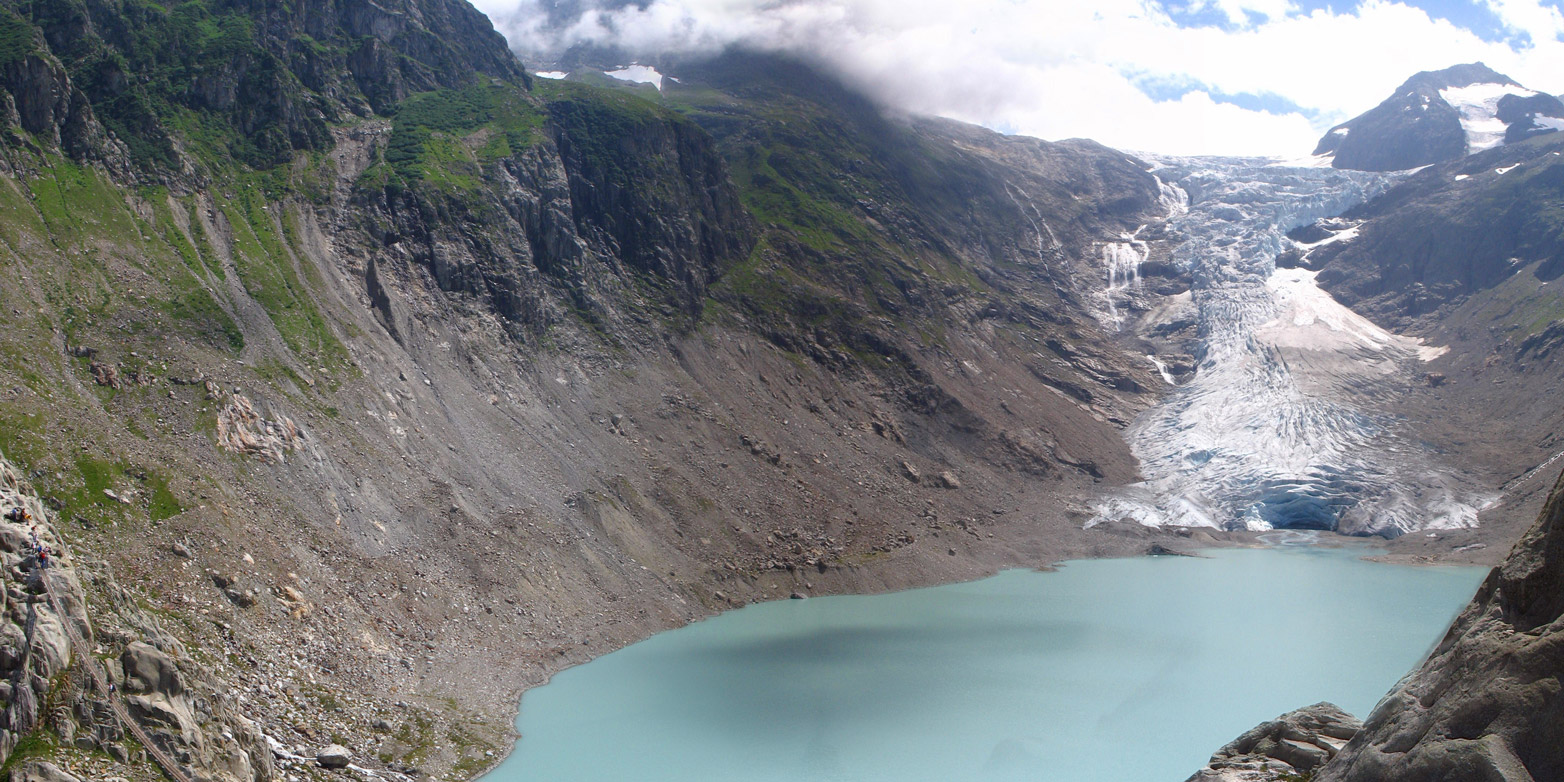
[{"left": 0, "top": 457, "right": 275, "bottom": 782}]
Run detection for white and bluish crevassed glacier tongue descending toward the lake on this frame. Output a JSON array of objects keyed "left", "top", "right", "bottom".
[{"left": 1093, "top": 158, "right": 1480, "bottom": 536}]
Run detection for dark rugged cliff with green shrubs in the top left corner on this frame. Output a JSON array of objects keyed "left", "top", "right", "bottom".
[{"left": 3, "top": 0, "right": 529, "bottom": 171}]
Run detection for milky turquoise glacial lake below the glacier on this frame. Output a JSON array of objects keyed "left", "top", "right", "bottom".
[{"left": 483, "top": 547, "right": 1486, "bottom": 782}]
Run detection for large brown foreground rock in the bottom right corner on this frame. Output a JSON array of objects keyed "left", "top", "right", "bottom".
[{"left": 1317, "top": 466, "right": 1564, "bottom": 782}]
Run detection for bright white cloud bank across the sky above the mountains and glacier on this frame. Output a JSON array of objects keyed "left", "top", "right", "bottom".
[{"left": 479, "top": 0, "right": 1564, "bottom": 156}]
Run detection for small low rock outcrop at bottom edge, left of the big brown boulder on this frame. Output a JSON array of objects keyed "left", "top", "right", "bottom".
[{"left": 1189, "top": 702, "right": 1362, "bottom": 782}]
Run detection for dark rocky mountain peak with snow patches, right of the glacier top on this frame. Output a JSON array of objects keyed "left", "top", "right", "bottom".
[{"left": 1314, "top": 63, "right": 1564, "bottom": 170}]
